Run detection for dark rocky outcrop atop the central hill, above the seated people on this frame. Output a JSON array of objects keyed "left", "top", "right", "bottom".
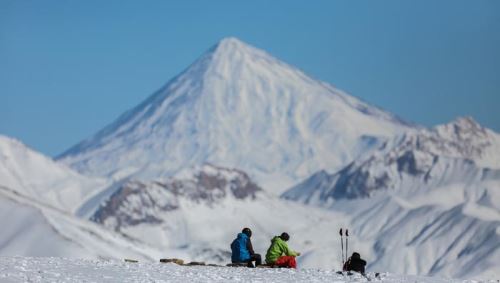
[{"left": 91, "top": 165, "right": 262, "bottom": 230}]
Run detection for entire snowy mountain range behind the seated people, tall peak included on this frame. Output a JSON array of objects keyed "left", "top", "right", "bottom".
[{"left": 0, "top": 38, "right": 500, "bottom": 278}]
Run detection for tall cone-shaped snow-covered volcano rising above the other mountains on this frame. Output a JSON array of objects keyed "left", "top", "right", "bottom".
[{"left": 58, "top": 38, "right": 412, "bottom": 191}]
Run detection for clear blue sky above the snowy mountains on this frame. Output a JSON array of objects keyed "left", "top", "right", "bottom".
[{"left": 0, "top": 0, "right": 500, "bottom": 156}]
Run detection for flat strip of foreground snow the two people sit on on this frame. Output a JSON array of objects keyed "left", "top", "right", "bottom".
[{"left": 0, "top": 257, "right": 495, "bottom": 283}]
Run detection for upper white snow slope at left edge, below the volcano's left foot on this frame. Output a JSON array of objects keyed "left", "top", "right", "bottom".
[{"left": 0, "top": 135, "right": 109, "bottom": 211}]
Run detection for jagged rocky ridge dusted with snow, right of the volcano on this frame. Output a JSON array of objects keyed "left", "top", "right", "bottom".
[{"left": 283, "top": 118, "right": 500, "bottom": 203}]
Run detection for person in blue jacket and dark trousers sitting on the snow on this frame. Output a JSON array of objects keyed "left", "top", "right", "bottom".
[{"left": 231, "top": 228, "right": 262, "bottom": 267}]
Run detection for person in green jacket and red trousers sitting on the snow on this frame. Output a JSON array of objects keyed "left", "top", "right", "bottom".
[{"left": 266, "top": 232, "right": 300, "bottom": 268}]
